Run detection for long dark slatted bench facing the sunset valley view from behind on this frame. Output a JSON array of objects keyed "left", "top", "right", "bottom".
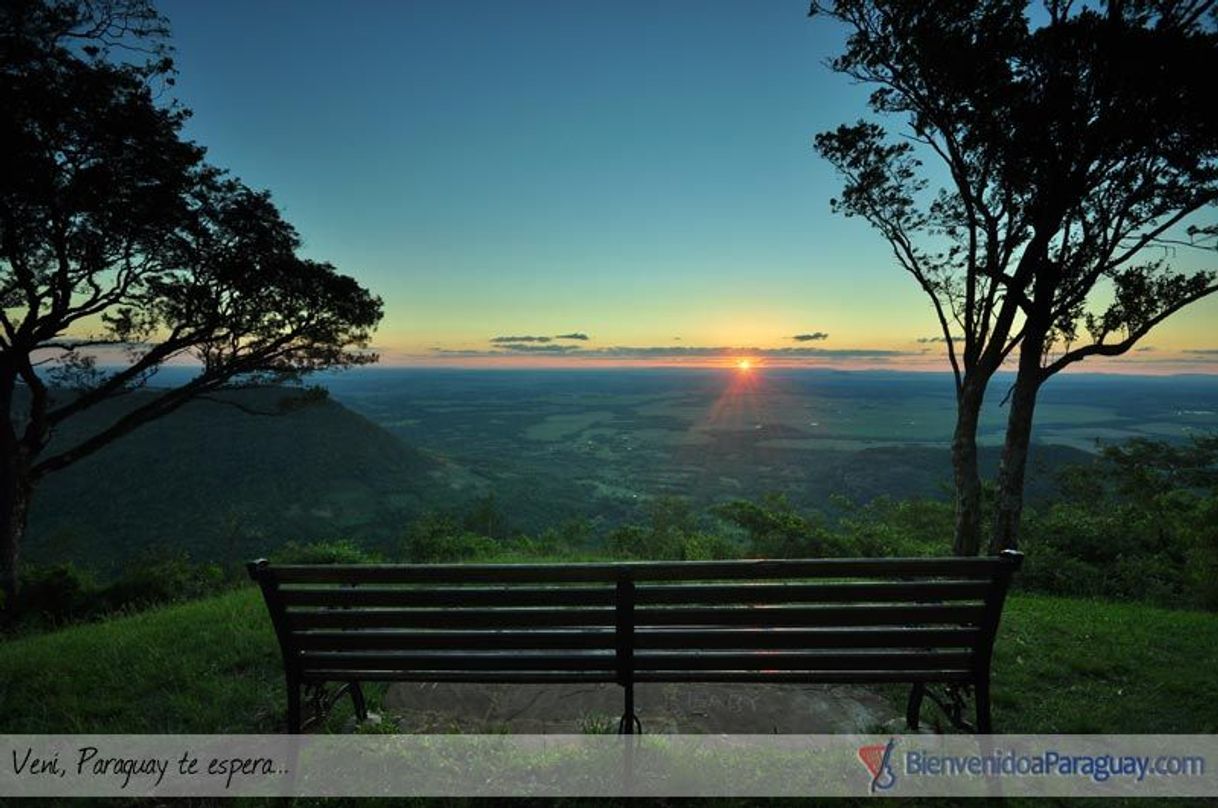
[{"left": 248, "top": 551, "right": 1022, "bottom": 732}]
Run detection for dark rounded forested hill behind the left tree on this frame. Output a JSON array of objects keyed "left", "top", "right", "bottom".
[{"left": 24, "top": 389, "right": 446, "bottom": 569}]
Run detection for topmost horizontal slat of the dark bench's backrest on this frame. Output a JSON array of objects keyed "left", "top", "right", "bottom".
[{"left": 267, "top": 557, "right": 1001, "bottom": 585}]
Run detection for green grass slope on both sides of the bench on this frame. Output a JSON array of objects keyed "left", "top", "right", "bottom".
[{"left": 0, "top": 589, "right": 1218, "bottom": 732}]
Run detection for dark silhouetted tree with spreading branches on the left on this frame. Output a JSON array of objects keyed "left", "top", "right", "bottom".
[{"left": 0, "top": 0, "right": 381, "bottom": 611}]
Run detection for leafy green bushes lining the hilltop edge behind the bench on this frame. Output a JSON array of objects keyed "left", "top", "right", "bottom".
[{"left": 16, "top": 435, "right": 1218, "bottom": 631}]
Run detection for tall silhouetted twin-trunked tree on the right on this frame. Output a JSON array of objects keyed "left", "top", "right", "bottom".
[{"left": 811, "top": 0, "right": 1218, "bottom": 555}]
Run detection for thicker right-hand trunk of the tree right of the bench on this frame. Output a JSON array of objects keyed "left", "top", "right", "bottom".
[{"left": 989, "top": 333, "right": 1045, "bottom": 553}]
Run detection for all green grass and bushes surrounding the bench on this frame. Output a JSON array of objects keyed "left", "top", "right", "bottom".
[{"left": 0, "top": 436, "right": 1218, "bottom": 804}]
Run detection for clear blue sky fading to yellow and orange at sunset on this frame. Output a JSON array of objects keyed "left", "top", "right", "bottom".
[{"left": 158, "top": 0, "right": 1218, "bottom": 372}]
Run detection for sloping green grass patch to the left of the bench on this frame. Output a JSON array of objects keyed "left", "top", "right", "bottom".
[{"left": 0, "top": 587, "right": 285, "bottom": 732}]
